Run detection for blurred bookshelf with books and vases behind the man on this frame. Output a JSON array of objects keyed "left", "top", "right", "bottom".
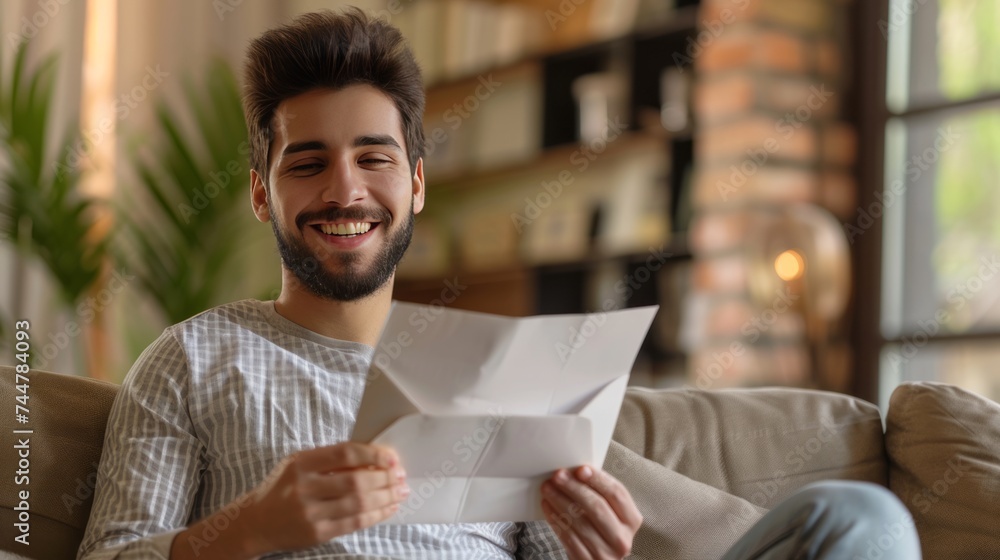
[{"left": 392, "top": 0, "right": 698, "bottom": 384}]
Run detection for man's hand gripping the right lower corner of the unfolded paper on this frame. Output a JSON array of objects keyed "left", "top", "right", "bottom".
[{"left": 542, "top": 465, "right": 642, "bottom": 560}]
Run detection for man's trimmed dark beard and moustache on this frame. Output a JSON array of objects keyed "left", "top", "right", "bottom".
[{"left": 271, "top": 199, "right": 413, "bottom": 301}]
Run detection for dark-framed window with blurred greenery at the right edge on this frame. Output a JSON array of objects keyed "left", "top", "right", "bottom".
[{"left": 858, "top": 0, "right": 1000, "bottom": 406}]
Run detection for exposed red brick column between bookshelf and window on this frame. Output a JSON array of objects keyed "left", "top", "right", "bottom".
[{"left": 688, "top": 0, "right": 857, "bottom": 389}]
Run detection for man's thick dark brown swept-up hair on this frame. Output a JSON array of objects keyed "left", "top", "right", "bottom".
[{"left": 243, "top": 8, "right": 424, "bottom": 180}]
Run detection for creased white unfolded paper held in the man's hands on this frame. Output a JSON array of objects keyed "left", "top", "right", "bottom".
[{"left": 351, "top": 302, "right": 657, "bottom": 524}]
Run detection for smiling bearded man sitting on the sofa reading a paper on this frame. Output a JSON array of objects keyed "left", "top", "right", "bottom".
[{"left": 79, "top": 10, "right": 919, "bottom": 560}]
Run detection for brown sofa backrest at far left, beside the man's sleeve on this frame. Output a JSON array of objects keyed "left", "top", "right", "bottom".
[{"left": 0, "top": 366, "right": 118, "bottom": 560}]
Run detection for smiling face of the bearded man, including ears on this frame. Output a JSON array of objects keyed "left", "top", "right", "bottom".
[{"left": 251, "top": 85, "right": 424, "bottom": 301}]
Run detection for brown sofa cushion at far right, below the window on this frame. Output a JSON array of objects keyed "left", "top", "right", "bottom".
[{"left": 886, "top": 382, "right": 1000, "bottom": 559}]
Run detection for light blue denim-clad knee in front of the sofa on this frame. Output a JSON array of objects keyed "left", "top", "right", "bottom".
[{"left": 723, "top": 481, "right": 920, "bottom": 560}]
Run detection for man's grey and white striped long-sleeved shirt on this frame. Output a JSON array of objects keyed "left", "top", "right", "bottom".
[{"left": 78, "top": 300, "right": 565, "bottom": 560}]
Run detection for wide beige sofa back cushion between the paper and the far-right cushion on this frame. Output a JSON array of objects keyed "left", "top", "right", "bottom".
[{"left": 614, "top": 388, "right": 887, "bottom": 509}]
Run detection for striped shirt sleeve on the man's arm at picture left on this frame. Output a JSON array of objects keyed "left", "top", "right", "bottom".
[{"left": 77, "top": 329, "right": 204, "bottom": 560}]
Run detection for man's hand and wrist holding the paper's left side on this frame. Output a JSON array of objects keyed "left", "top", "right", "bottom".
[{"left": 171, "top": 442, "right": 410, "bottom": 559}]
